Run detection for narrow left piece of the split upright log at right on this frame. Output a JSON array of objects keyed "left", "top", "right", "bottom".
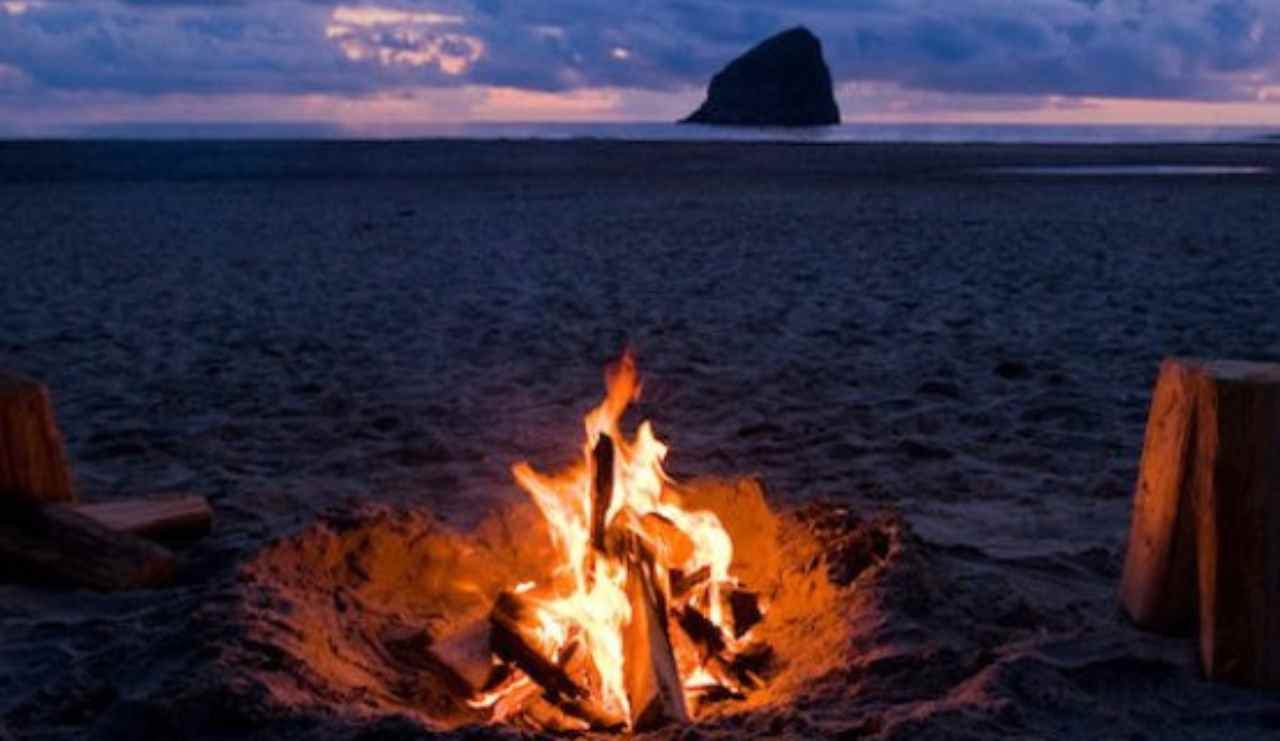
[{"left": 1120, "top": 360, "right": 1201, "bottom": 633}]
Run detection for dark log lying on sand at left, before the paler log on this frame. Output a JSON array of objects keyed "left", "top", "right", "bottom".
[{"left": 0, "top": 500, "right": 177, "bottom": 591}]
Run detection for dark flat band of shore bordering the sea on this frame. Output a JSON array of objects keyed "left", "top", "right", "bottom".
[{"left": 0, "top": 139, "right": 1280, "bottom": 187}]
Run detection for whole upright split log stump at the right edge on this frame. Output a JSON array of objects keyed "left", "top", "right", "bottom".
[{"left": 1121, "top": 360, "right": 1280, "bottom": 687}]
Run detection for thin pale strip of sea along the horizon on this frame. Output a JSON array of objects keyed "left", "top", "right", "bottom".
[{"left": 0, "top": 122, "right": 1280, "bottom": 145}]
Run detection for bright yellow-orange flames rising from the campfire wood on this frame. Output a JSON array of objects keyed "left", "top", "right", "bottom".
[{"left": 501, "top": 352, "right": 733, "bottom": 718}]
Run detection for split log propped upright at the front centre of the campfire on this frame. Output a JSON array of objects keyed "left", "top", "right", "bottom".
[{"left": 622, "top": 549, "right": 689, "bottom": 729}]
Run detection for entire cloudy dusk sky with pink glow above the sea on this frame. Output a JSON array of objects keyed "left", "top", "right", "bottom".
[{"left": 0, "top": 0, "right": 1280, "bottom": 134}]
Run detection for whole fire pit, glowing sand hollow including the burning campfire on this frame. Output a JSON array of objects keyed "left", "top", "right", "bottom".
[{"left": 244, "top": 356, "right": 897, "bottom": 732}]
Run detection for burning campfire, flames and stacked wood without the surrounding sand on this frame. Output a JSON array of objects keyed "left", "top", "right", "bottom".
[{"left": 470, "top": 353, "right": 769, "bottom": 731}]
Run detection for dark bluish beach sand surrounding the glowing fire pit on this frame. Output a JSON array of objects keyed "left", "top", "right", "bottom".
[{"left": 0, "top": 141, "right": 1280, "bottom": 740}]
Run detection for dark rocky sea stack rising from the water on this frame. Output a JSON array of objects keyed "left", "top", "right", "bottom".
[{"left": 681, "top": 26, "right": 840, "bottom": 127}]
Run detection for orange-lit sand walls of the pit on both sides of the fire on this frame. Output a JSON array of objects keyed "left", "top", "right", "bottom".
[{"left": 237, "top": 481, "right": 904, "bottom": 729}]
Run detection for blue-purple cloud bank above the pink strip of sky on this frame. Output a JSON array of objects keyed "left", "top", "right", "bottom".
[{"left": 0, "top": 0, "right": 1280, "bottom": 106}]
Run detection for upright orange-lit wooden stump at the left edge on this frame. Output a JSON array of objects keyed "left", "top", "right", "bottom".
[{"left": 0, "top": 371, "right": 76, "bottom": 502}]
